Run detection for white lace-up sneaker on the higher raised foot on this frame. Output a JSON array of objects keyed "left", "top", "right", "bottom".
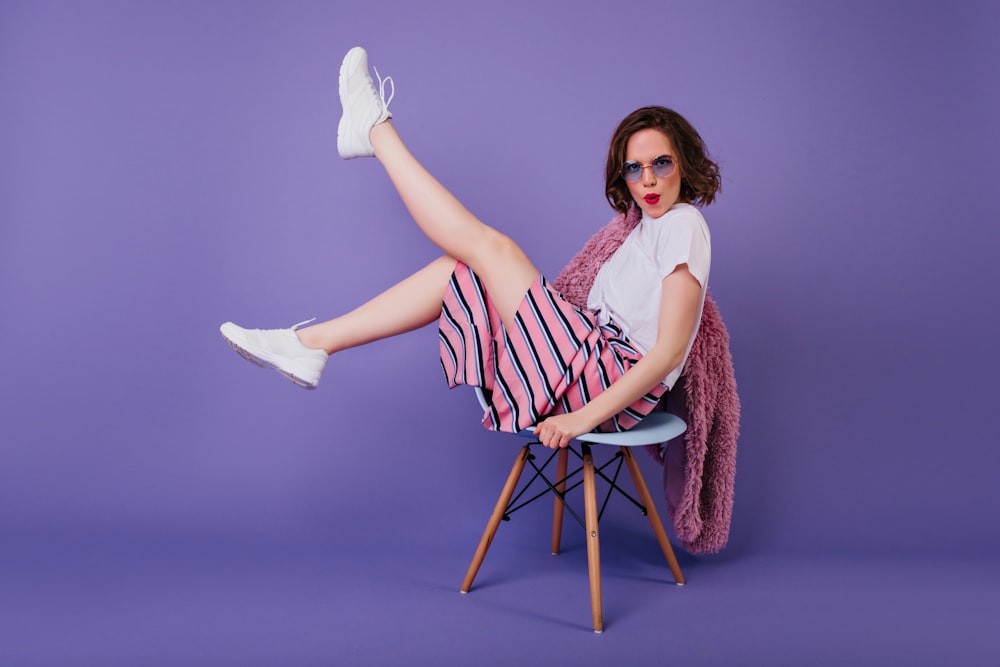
[{"left": 337, "top": 46, "right": 396, "bottom": 159}]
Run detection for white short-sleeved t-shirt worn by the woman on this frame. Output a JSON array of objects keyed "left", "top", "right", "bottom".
[{"left": 587, "top": 204, "right": 712, "bottom": 389}]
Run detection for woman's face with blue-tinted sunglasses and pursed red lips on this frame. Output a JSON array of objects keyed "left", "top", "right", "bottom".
[{"left": 625, "top": 128, "right": 681, "bottom": 218}]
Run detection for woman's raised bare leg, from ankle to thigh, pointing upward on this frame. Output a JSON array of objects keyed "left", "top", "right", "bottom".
[{"left": 370, "top": 121, "right": 539, "bottom": 326}]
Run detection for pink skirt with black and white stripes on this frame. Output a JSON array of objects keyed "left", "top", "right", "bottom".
[{"left": 438, "top": 262, "right": 666, "bottom": 433}]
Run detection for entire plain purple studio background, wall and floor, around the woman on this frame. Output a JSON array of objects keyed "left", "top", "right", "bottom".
[{"left": 0, "top": 0, "right": 1000, "bottom": 665}]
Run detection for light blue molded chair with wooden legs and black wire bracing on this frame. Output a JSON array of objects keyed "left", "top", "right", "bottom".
[{"left": 461, "top": 387, "right": 687, "bottom": 633}]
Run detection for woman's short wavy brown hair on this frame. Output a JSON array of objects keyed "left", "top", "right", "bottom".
[{"left": 604, "top": 106, "right": 722, "bottom": 213}]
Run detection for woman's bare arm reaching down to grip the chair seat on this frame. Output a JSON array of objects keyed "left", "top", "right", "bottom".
[{"left": 535, "top": 264, "right": 701, "bottom": 448}]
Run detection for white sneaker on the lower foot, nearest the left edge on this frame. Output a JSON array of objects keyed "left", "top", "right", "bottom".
[{"left": 219, "top": 320, "right": 330, "bottom": 389}]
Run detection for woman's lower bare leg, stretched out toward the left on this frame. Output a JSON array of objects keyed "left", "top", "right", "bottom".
[{"left": 297, "top": 256, "right": 455, "bottom": 354}]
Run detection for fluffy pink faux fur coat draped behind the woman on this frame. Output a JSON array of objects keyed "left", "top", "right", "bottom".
[{"left": 552, "top": 208, "right": 740, "bottom": 553}]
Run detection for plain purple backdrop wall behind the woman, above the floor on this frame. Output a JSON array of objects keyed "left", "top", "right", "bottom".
[{"left": 0, "top": 0, "right": 1000, "bottom": 664}]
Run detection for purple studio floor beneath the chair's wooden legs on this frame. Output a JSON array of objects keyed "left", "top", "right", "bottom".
[{"left": 0, "top": 520, "right": 1000, "bottom": 667}]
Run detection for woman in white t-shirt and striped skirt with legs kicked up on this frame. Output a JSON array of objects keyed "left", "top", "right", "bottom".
[{"left": 222, "top": 47, "right": 720, "bottom": 448}]
